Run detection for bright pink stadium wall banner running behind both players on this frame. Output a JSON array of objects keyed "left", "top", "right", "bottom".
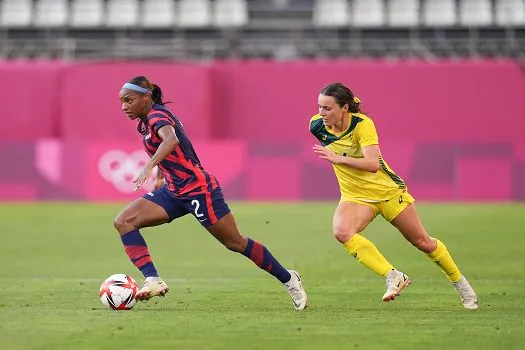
[{"left": 0, "top": 61, "right": 525, "bottom": 201}]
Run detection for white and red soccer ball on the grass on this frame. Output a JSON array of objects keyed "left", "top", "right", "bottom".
[{"left": 100, "top": 273, "right": 139, "bottom": 310}]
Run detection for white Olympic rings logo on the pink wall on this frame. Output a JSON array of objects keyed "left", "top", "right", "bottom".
[{"left": 98, "top": 149, "right": 156, "bottom": 193}]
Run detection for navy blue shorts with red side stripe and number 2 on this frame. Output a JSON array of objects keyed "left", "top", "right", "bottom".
[{"left": 142, "top": 186, "right": 230, "bottom": 227}]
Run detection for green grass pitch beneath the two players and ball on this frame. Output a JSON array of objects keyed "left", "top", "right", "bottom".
[{"left": 0, "top": 202, "right": 525, "bottom": 350}]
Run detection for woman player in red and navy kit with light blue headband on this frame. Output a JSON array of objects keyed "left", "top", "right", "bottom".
[{"left": 115, "top": 76, "right": 307, "bottom": 310}]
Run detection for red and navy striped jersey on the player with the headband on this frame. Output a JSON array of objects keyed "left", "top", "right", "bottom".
[{"left": 139, "top": 104, "right": 219, "bottom": 198}]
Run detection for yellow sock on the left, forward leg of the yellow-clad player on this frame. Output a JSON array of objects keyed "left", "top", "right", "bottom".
[{"left": 343, "top": 234, "right": 394, "bottom": 276}]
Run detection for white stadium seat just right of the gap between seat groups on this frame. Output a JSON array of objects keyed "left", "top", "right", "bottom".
[{"left": 313, "top": 0, "right": 350, "bottom": 27}]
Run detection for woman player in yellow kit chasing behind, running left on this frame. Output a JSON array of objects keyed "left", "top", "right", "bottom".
[{"left": 310, "top": 83, "right": 478, "bottom": 309}]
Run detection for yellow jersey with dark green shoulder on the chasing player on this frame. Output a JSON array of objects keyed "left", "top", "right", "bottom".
[{"left": 310, "top": 113, "right": 406, "bottom": 202}]
